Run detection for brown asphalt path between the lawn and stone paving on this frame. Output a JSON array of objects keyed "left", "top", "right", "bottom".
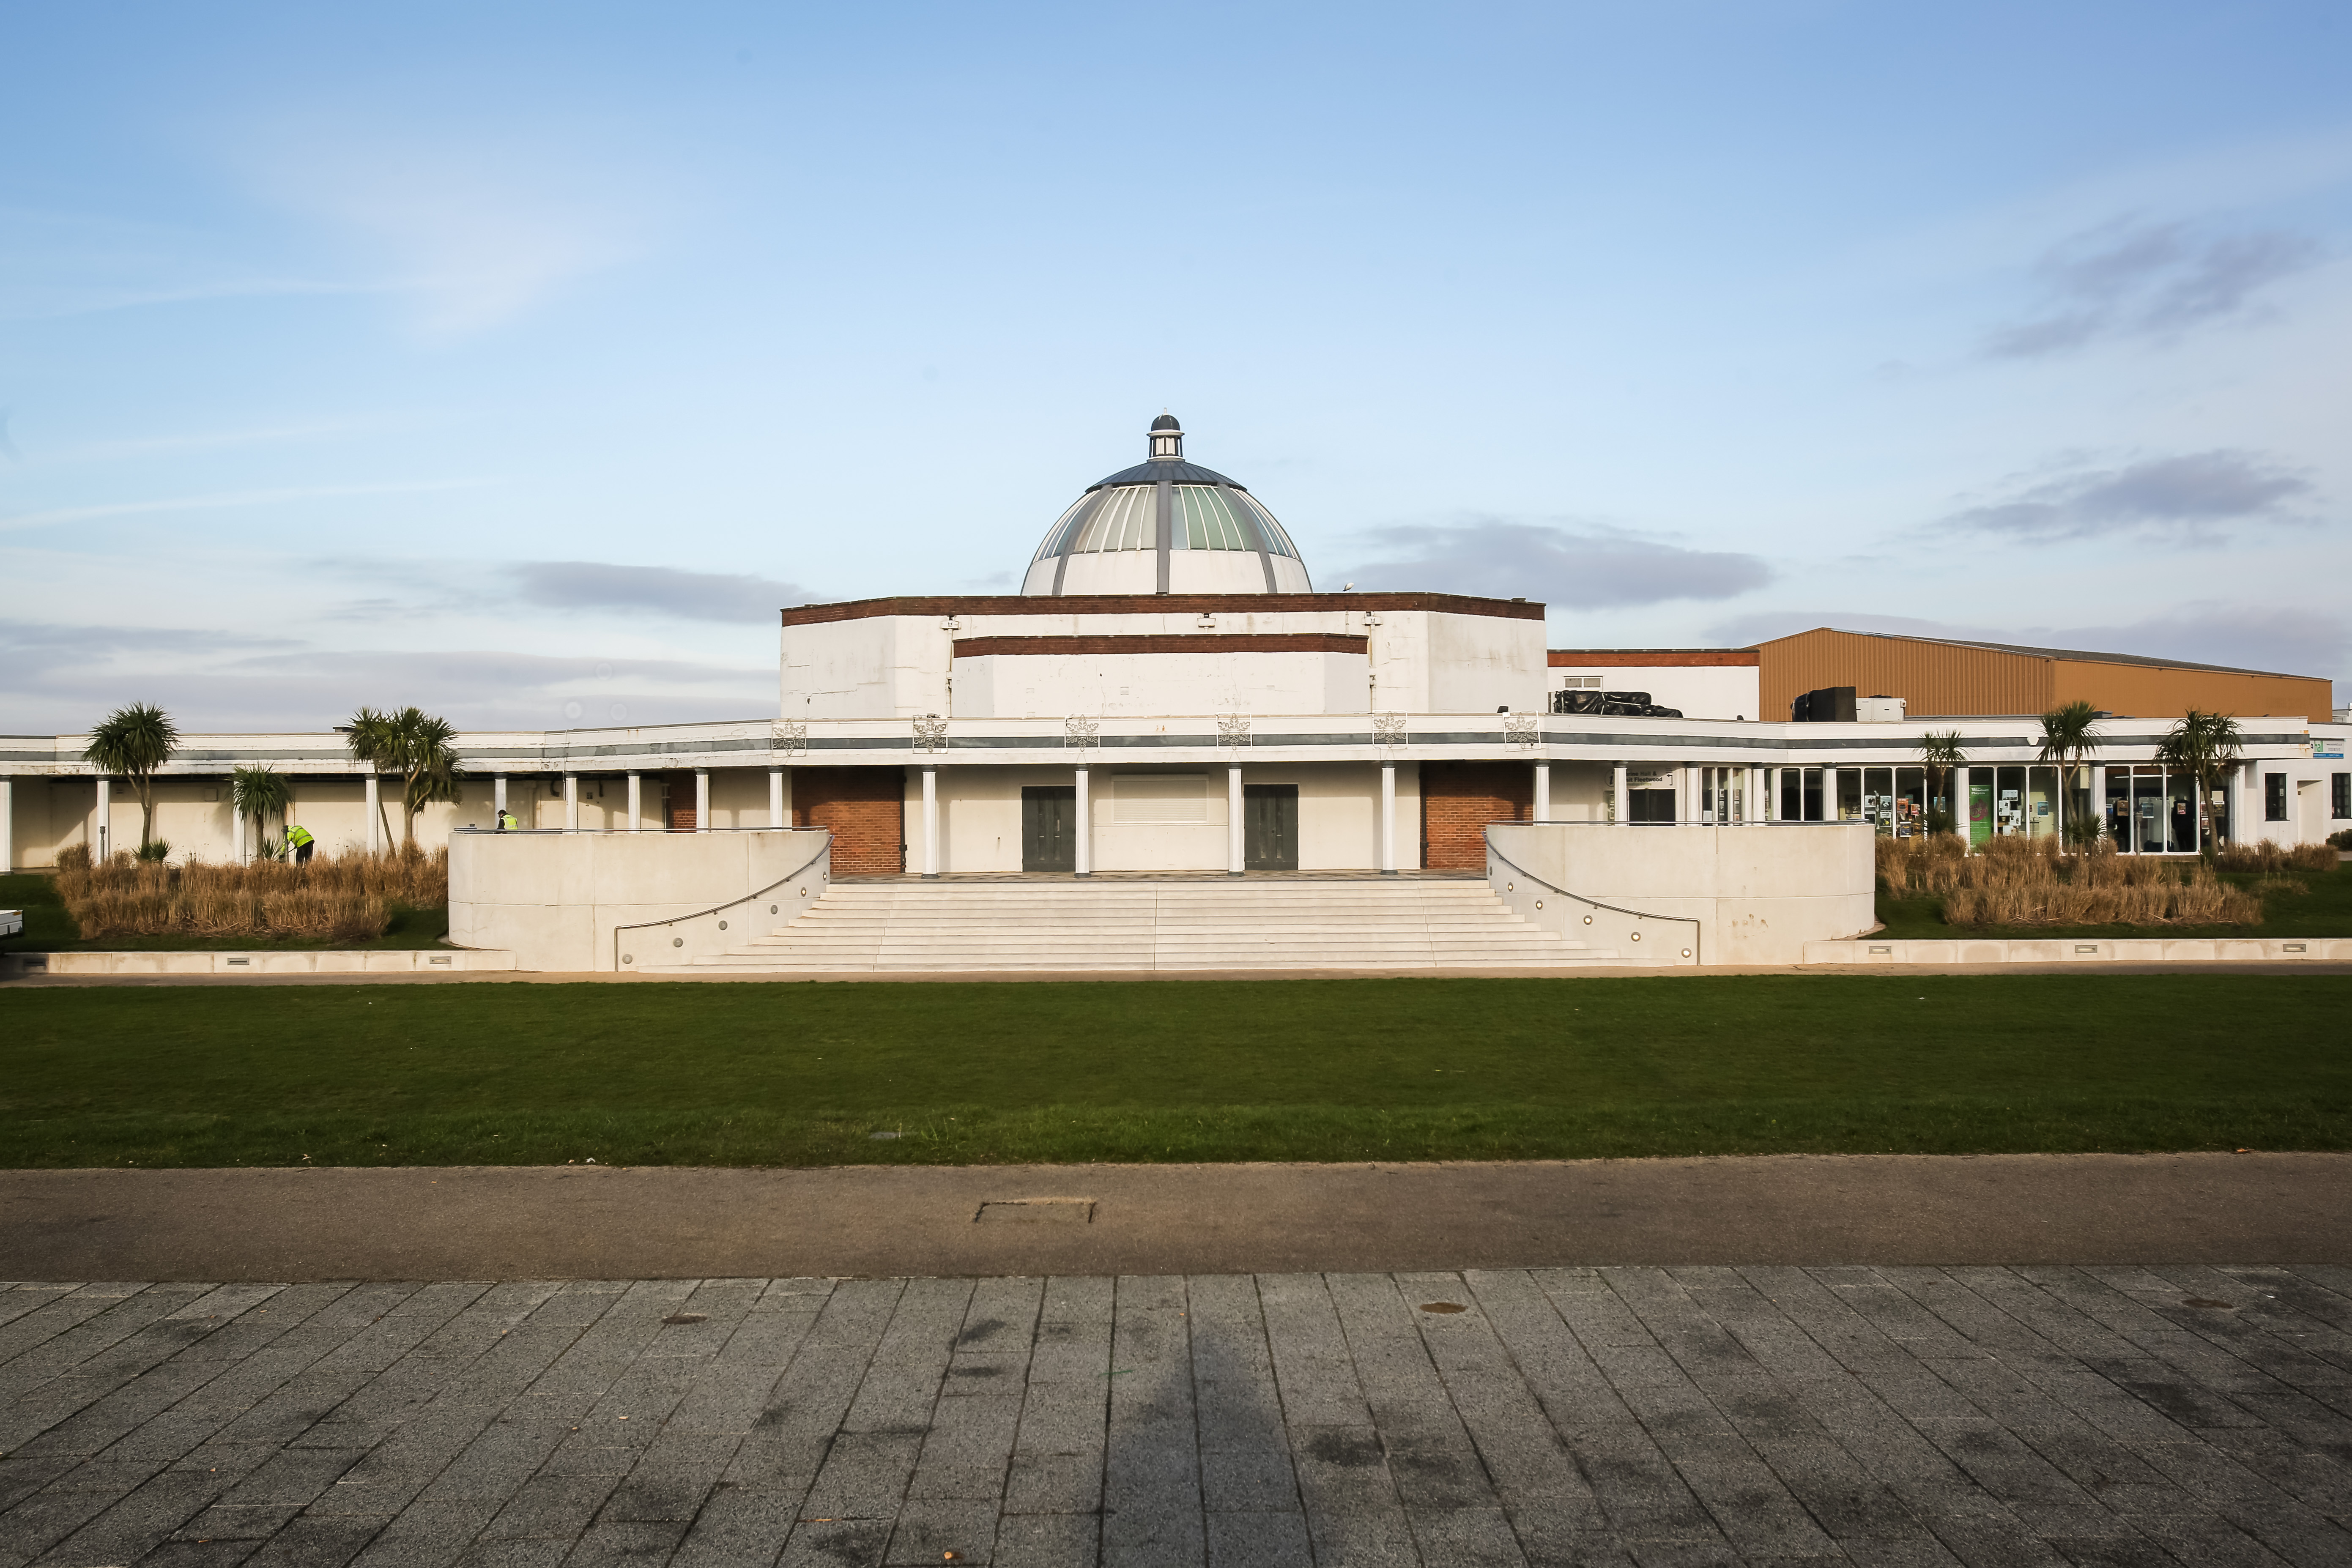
[{"left": 0, "top": 1152, "right": 2352, "bottom": 1281}]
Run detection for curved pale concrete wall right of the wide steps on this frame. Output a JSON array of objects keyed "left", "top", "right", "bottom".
[{"left": 1487, "top": 823, "right": 1877, "bottom": 964}]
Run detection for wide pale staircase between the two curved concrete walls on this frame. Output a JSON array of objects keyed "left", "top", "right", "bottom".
[{"left": 694, "top": 877, "right": 1623, "bottom": 973}]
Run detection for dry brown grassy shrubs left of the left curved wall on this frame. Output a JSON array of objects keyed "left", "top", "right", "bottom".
[{"left": 57, "top": 844, "right": 449, "bottom": 943}]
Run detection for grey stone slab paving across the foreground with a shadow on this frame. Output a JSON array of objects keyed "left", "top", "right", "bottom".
[{"left": 0, "top": 1265, "right": 2352, "bottom": 1568}]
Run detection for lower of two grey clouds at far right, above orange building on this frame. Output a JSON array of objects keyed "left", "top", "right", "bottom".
[{"left": 1945, "top": 449, "right": 2314, "bottom": 543}]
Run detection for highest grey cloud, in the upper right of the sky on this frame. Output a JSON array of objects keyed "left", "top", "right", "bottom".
[{"left": 1985, "top": 219, "right": 2322, "bottom": 360}]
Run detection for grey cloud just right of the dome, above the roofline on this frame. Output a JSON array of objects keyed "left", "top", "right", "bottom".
[{"left": 1322, "top": 520, "right": 1774, "bottom": 609}]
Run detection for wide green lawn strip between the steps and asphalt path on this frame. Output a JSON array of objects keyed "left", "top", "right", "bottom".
[{"left": 0, "top": 976, "right": 2352, "bottom": 1166}]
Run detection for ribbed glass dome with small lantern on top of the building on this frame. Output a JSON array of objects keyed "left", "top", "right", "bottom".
[{"left": 1021, "top": 414, "right": 1315, "bottom": 595}]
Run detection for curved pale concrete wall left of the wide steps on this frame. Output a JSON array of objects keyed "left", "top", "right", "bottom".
[{"left": 449, "top": 827, "right": 832, "bottom": 973}]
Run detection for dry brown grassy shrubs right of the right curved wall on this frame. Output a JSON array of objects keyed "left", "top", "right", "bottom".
[{"left": 1877, "top": 835, "right": 2263, "bottom": 926}]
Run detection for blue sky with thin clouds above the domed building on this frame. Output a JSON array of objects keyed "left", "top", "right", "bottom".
[{"left": 0, "top": 0, "right": 2352, "bottom": 733}]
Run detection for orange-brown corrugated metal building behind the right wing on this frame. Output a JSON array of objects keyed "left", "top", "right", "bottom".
[{"left": 1757, "top": 625, "right": 2331, "bottom": 724}]
